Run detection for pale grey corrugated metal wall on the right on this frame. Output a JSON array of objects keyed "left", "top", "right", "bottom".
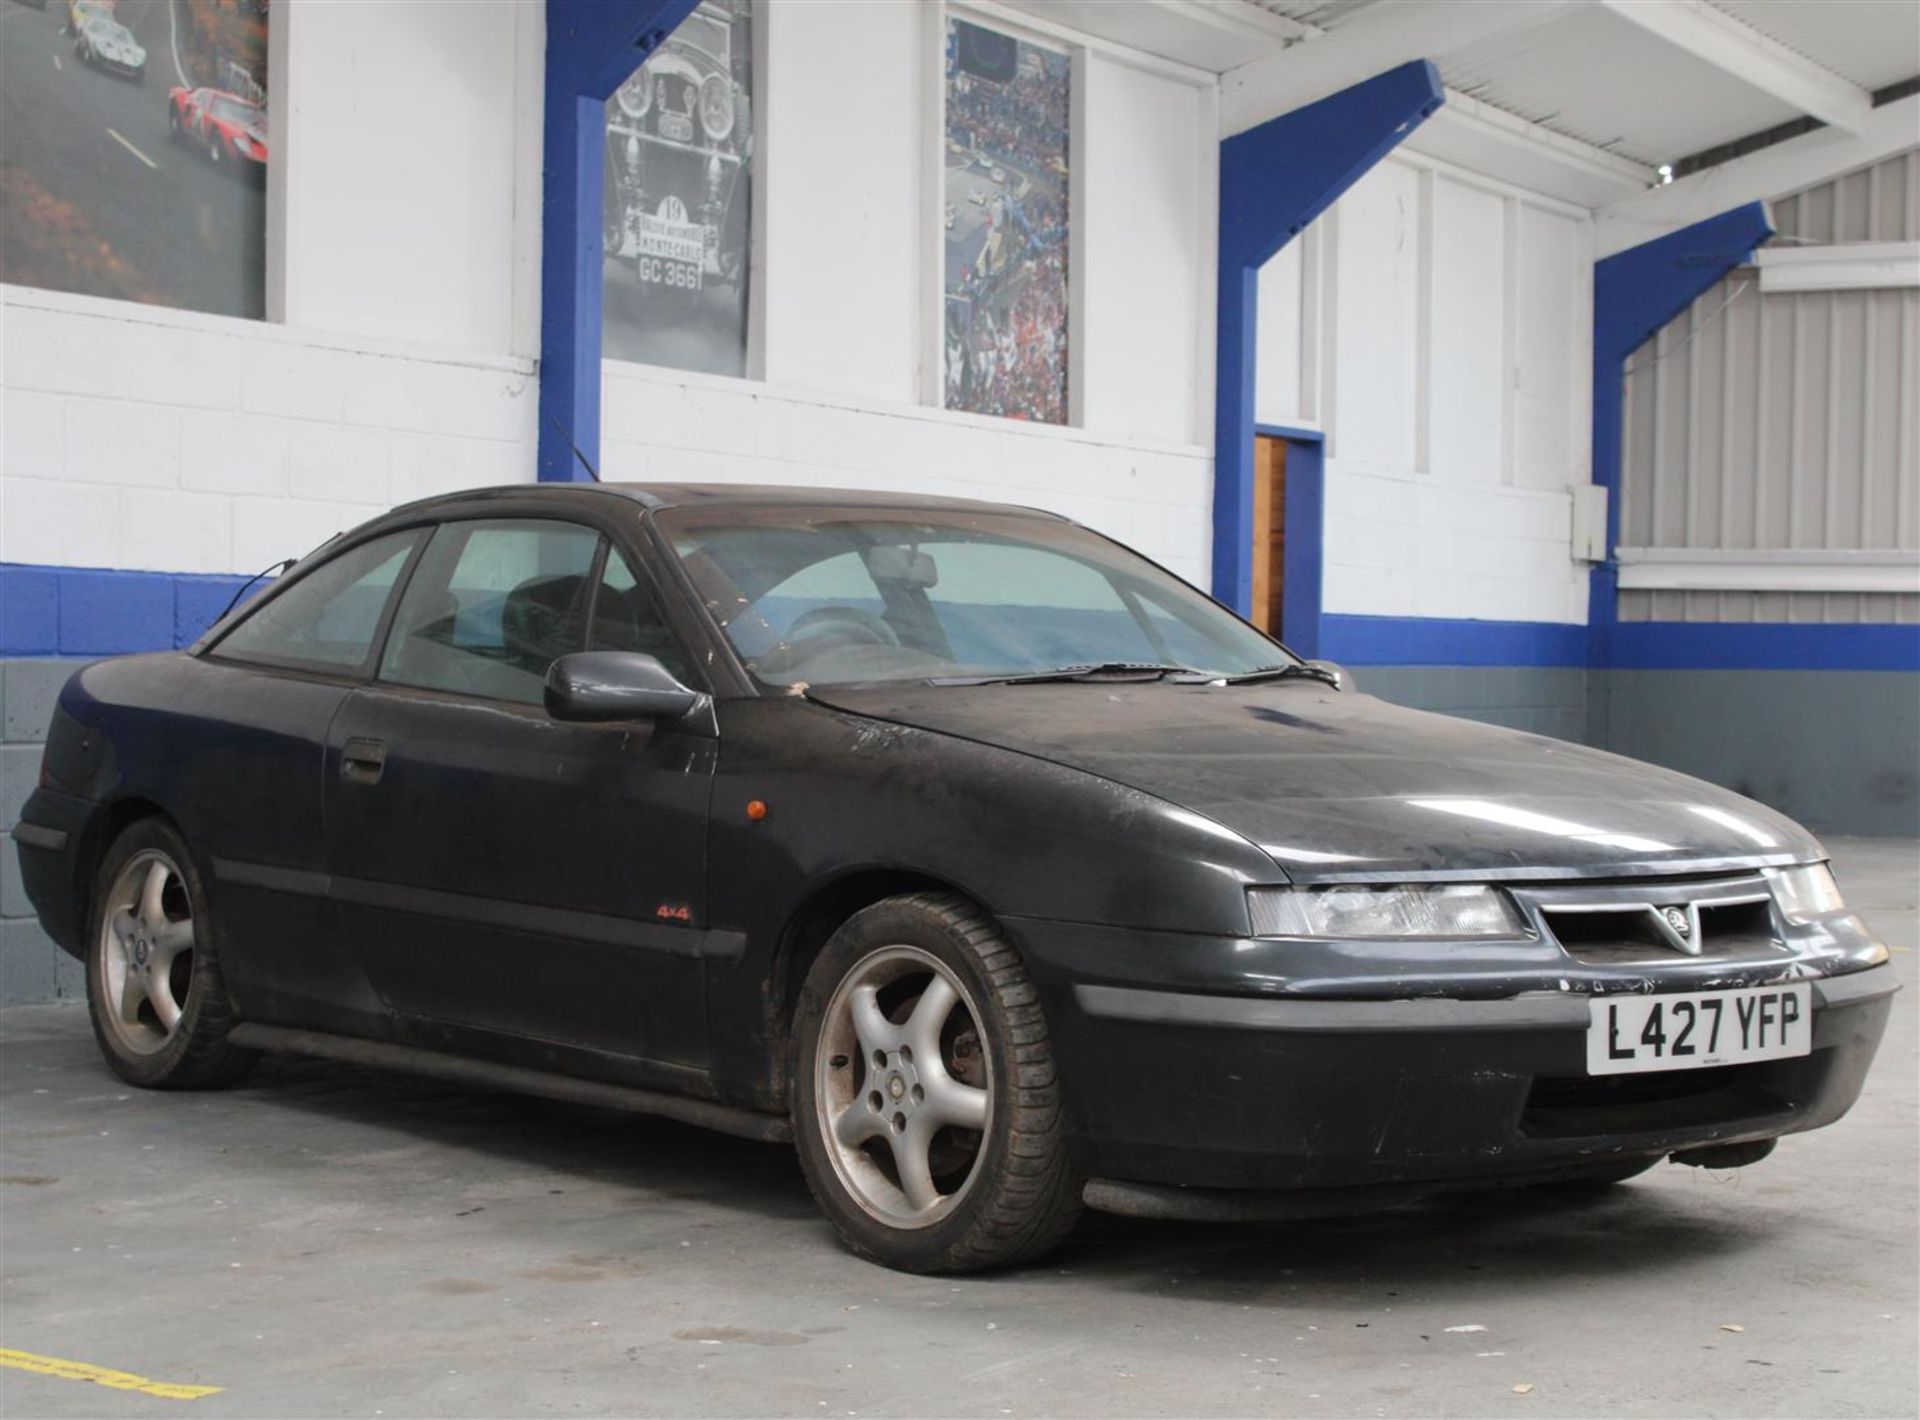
[{"left": 1620, "top": 148, "right": 1920, "bottom": 624}]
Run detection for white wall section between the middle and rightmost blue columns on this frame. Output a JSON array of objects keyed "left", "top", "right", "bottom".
[{"left": 1256, "top": 152, "right": 1594, "bottom": 624}]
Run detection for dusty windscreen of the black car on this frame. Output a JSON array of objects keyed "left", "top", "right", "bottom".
[{"left": 659, "top": 509, "right": 1292, "bottom": 685}]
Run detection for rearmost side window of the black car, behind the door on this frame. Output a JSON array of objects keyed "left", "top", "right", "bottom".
[{"left": 213, "top": 528, "right": 424, "bottom": 670}]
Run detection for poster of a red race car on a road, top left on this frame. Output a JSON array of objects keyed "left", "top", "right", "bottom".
[{"left": 0, "top": 0, "right": 269, "bottom": 319}]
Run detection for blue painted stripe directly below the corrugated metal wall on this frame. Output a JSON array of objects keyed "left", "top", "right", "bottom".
[{"left": 1609, "top": 622, "right": 1920, "bottom": 672}]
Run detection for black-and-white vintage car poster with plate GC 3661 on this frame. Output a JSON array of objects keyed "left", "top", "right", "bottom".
[{"left": 601, "top": 0, "right": 753, "bottom": 374}]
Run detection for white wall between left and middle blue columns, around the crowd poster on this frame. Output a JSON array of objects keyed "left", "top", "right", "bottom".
[{"left": 601, "top": 0, "right": 1215, "bottom": 585}]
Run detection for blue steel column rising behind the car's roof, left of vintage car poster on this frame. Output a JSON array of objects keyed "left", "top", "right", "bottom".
[{"left": 540, "top": 0, "right": 697, "bottom": 484}]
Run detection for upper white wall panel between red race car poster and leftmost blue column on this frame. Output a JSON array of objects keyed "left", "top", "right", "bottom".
[{"left": 273, "top": 0, "right": 545, "bottom": 357}]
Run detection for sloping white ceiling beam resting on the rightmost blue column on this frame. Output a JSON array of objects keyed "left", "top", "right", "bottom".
[{"left": 1594, "top": 94, "right": 1920, "bottom": 257}]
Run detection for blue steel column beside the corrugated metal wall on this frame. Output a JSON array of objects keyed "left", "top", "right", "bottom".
[{"left": 1586, "top": 201, "right": 1774, "bottom": 668}]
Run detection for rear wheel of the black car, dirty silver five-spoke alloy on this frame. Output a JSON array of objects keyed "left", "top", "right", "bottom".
[{"left": 86, "top": 817, "right": 255, "bottom": 1090}]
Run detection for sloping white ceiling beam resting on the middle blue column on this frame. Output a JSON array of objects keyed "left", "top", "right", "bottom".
[{"left": 1219, "top": 0, "right": 1578, "bottom": 138}]
